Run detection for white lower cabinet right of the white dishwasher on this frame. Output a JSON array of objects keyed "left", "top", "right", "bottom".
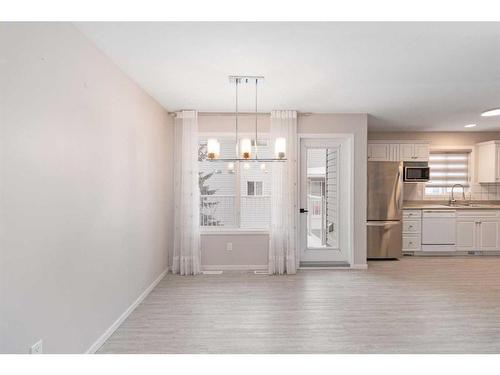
[{"left": 456, "top": 210, "right": 500, "bottom": 251}]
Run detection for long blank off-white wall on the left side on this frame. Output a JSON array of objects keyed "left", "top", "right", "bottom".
[{"left": 0, "top": 23, "right": 172, "bottom": 353}]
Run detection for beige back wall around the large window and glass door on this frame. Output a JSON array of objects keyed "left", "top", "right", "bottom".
[{"left": 199, "top": 114, "right": 367, "bottom": 268}]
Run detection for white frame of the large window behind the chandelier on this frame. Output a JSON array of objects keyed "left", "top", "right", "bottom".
[{"left": 198, "top": 131, "right": 270, "bottom": 235}]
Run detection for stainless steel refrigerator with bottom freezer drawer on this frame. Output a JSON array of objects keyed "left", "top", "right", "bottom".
[{"left": 366, "top": 161, "right": 403, "bottom": 259}]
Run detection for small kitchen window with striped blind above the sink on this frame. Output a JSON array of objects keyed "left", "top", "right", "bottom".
[{"left": 425, "top": 151, "right": 470, "bottom": 196}]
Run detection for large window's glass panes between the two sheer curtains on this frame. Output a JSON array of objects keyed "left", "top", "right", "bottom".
[{"left": 198, "top": 136, "right": 272, "bottom": 229}]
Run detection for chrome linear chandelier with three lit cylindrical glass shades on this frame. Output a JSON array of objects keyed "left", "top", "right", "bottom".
[{"left": 207, "top": 76, "right": 286, "bottom": 162}]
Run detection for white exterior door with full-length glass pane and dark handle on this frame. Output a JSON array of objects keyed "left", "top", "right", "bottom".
[{"left": 299, "top": 138, "right": 352, "bottom": 266}]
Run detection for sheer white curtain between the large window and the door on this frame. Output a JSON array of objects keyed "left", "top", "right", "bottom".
[{"left": 269, "top": 111, "right": 298, "bottom": 275}]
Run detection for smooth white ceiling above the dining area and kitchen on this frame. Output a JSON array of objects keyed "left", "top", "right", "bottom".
[{"left": 77, "top": 22, "right": 500, "bottom": 131}]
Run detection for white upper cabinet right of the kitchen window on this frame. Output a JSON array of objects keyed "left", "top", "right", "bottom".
[{"left": 476, "top": 141, "right": 500, "bottom": 183}]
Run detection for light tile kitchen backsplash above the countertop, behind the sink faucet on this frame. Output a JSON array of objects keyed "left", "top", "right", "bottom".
[{"left": 403, "top": 183, "right": 500, "bottom": 201}]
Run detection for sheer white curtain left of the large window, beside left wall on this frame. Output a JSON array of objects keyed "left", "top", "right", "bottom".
[{"left": 172, "top": 111, "right": 201, "bottom": 275}]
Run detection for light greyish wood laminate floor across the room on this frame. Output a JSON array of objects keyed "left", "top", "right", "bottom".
[{"left": 99, "top": 257, "right": 500, "bottom": 353}]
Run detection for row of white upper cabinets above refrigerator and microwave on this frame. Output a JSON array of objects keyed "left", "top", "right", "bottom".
[{"left": 368, "top": 141, "right": 429, "bottom": 161}]
